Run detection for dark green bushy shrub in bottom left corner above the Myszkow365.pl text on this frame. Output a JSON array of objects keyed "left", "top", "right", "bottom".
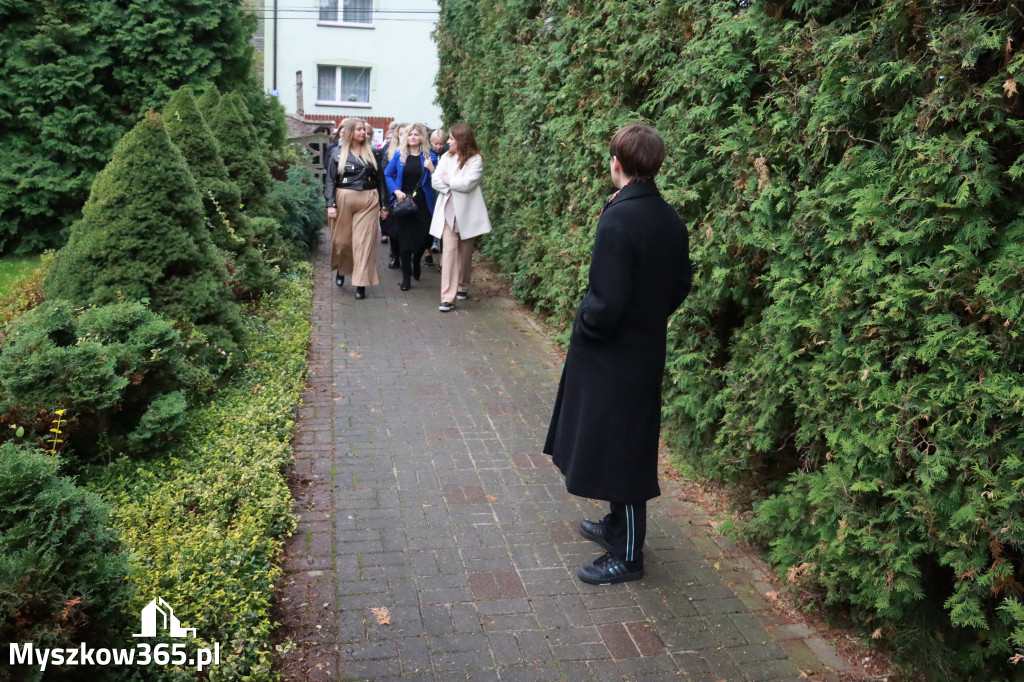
[{"left": 0, "top": 442, "right": 132, "bottom": 680}]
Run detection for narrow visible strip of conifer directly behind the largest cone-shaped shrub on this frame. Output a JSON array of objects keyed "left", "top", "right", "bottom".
[{"left": 163, "top": 85, "right": 274, "bottom": 293}]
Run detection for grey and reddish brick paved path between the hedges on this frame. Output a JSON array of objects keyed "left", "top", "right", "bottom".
[{"left": 282, "top": 231, "right": 856, "bottom": 682}]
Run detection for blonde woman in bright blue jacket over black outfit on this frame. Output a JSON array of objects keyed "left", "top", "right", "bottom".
[{"left": 384, "top": 123, "right": 437, "bottom": 291}]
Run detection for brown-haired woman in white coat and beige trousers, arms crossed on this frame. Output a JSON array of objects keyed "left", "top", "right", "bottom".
[{"left": 430, "top": 123, "right": 490, "bottom": 312}]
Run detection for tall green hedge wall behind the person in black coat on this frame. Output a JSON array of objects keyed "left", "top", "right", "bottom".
[{"left": 436, "top": 0, "right": 1024, "bottom": 680}]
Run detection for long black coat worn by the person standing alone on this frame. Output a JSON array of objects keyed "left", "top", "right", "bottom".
[{"left": 544, "top": 182, "right": 691, "bottom": 504}]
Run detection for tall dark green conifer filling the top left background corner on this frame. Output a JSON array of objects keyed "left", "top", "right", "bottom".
[{"left": 0, "top": 0, "right": 255, "bottom": 251}]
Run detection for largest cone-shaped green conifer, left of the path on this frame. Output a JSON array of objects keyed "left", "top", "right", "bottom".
[{"left": 43, "top": 112, "right": 242, "bottom": 370}]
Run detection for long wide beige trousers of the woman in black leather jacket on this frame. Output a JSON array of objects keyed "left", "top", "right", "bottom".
[{"left": 331, "top": 189, "right": 380, "bottom": 287}]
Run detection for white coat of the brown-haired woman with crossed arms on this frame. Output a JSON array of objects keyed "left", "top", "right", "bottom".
[{"left": 430, "top": 152, "right": 490, "bottom": 240}]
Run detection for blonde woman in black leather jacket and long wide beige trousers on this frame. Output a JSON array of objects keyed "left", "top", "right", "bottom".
[{"left": 324, "top": 118, "right": 388, "bottom": 300}]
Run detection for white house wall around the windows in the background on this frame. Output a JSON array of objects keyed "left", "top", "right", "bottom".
[{"left": 263, "top": 0, "right": 441, "bottom": 126}]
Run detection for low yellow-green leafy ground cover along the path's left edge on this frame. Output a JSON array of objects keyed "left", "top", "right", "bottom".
[{"left": 84, "top": 264, "right": 312, "bottom": 680}]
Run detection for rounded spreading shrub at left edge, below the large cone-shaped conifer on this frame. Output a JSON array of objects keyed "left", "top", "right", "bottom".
[{"left": 0, "top": 300, "right": 201, "bottom": 460}]
